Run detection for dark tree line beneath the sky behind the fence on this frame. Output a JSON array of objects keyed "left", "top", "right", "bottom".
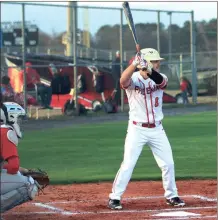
[{"left": 39, "top": 19, "right": 217, "bottom": 53}]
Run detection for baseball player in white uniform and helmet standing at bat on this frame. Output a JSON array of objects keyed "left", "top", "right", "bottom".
[{"left": 108, "top": 48, "right": 185, "bottom": 209}]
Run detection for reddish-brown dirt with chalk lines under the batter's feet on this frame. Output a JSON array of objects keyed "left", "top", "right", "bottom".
[{"left": 4, "top": 180, "right": 217, "bottom": 220}]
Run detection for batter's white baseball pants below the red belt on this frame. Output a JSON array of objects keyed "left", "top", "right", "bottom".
[{"left": 109, "top": 121, "right": 178, "bottom": 200}]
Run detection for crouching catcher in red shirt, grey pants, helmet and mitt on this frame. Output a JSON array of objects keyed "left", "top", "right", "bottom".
[{"left": 0, "top": 102, "right": 49, "bottom": 217}]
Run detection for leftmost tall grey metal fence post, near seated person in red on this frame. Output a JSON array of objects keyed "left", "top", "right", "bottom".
[{"left": 22, "top": 3, "right": 28, "bottom": 115}]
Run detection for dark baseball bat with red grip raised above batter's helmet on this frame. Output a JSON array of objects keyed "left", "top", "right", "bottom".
[{"left": 122, "top": 2, "right": 140, "bottom": 52}]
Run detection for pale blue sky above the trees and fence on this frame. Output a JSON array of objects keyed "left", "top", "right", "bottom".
[{"left": 1, "top": 1, "right": 217, "bottom": 34}]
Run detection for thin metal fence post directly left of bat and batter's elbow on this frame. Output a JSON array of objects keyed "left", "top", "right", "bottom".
[{"left": 120, "top": 9, "right": 124, "bottom": 112}]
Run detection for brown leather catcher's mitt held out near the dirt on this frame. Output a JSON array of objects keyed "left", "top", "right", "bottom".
[{"left": 23, "top": 169, "right": 50, "bottom": 190}]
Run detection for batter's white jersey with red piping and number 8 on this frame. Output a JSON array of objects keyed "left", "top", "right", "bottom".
[{"left": 125, "top": 71, "right": 168, "bottom": 124}]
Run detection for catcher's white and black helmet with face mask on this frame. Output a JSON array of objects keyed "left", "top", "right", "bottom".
[{"left": 1, "top": 102, "right": 26, "bottom": 138}]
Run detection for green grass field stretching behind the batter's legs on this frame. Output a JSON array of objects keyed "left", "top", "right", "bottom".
[{"left": 19, "top": 112, "right": 216, "bottom": 184}]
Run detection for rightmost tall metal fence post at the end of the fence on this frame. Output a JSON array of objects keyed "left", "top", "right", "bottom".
[{"left": 190, "top": 11, "right": 198, "bottom": 104}]
